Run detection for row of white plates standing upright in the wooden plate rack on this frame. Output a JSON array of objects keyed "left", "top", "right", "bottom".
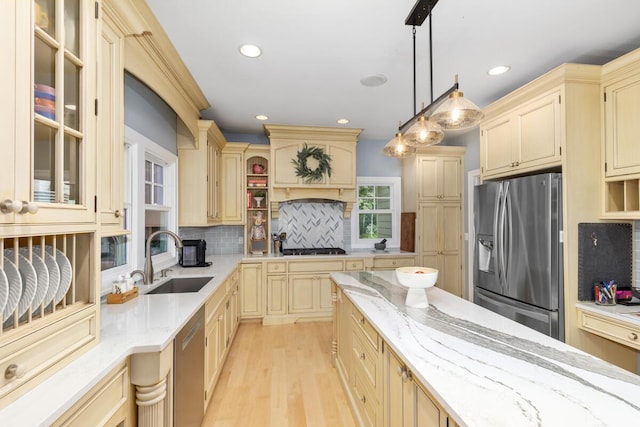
[{"left": 0, "top": 245, "right": 72, "bottom": 326}]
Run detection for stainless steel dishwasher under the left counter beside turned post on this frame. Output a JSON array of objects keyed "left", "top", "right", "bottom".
[{"left": 173, "top": 307, "right": 204, "bottom": 427}]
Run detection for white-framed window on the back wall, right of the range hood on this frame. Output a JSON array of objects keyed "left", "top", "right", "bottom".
[{"left": 351, "top": 177, "right": 401, "bottom": 248}]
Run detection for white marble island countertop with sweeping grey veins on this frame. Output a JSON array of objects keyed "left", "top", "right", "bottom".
[{"left": 331, "top": 271, "right": 640, "bottom": 427}]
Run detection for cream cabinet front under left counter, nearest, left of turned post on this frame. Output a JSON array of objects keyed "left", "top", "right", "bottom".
[{"left": 53, "top": 359, "right": 137, "bottom": 427}]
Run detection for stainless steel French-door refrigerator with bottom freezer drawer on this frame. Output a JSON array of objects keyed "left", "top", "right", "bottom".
[{"left": 473, "top": 173, "right": 564, "bottom": 341}]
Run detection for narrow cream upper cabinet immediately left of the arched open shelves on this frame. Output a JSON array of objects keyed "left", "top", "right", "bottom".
[{"left": 220, "top": 142, "right": 249, "bottom": 225}]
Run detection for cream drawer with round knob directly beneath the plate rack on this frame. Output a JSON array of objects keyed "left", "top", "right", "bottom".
[{"left": 0, "top": 310, "right": 96, "bottom": 407}]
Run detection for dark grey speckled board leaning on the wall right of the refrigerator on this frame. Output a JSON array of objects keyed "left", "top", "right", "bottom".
[{"left": 578, "top": 223, "right": 633, "bottom": 301}]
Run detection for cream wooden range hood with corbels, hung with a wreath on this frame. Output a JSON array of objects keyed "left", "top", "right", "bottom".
[{"left": 264, "top": 125, "right": 362, "bottom": 218}]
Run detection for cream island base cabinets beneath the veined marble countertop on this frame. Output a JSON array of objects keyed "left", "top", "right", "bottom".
[{"left": 331, "top": 282, "right": 457, "bottom": 427}]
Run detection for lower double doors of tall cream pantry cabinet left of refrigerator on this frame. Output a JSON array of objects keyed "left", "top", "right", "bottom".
[{"left": 418, "top": 203, "right": 463, "bottom": 297}]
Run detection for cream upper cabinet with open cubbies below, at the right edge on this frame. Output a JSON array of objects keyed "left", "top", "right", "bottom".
[{"left": 602, "top": 50, "right": 640, "bottom": 219}]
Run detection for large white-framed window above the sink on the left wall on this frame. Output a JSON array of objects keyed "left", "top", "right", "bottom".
[{"left": 100, "top": 126, "right": 178, "bottom": 295}]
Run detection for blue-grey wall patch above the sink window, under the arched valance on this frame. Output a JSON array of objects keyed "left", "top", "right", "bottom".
[{"left": 124, "top": 73, "right": 178, "bottom": 155}]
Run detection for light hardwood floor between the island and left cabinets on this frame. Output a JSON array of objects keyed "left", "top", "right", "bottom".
[{"left": 202, "top": 322, "right": 355, "bottom": 427}]
